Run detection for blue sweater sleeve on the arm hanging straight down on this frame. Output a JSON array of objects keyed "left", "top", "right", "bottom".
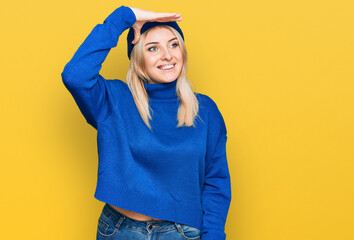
[{"left": 201, "top": 97, "right": 231, "bottom": 240}]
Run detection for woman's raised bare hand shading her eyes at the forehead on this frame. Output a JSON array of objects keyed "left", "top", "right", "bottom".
[{"left": 130, "top": 7, "right": 182, "bottom": 44}]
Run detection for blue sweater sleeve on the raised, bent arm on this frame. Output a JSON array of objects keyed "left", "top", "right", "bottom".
[{"left": 61, "top": 6, "right": 136, "bottom": 128}]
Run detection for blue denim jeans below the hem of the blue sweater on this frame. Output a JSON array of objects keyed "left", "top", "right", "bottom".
[{"left": 97, "top": 203, "right": 200, "bottom": 240}]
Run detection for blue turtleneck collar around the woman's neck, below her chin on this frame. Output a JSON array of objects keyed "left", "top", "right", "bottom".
[{"left": 143, "top": 79, "right": 177, "bottom": 100}]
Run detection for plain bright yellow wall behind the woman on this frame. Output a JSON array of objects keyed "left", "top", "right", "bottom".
[{"left": 0, "top": 0, "right": 354, "bottom": 240}]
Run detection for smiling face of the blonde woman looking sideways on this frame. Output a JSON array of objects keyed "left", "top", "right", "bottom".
[{"left": 144, "top": 27, "right": 183, "bottom": 83}]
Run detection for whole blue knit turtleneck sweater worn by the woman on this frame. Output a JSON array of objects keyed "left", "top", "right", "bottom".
[{"left": 62, "top": 6, "right": 231, "bottom": 240}]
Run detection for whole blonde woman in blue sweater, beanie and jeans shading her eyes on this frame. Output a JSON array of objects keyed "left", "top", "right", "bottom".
[{"left": 62, "top": 6, "right": 231, "bottom": 240}]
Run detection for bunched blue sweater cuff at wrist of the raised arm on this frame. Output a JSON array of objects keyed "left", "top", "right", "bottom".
[{"left": 104, "top": 6, "right": 136, "bottom": 29}]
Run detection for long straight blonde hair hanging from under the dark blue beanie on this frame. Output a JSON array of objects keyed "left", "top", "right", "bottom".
[{"left": 126, "top": 25, "right": 199, "bottom": 130}]
